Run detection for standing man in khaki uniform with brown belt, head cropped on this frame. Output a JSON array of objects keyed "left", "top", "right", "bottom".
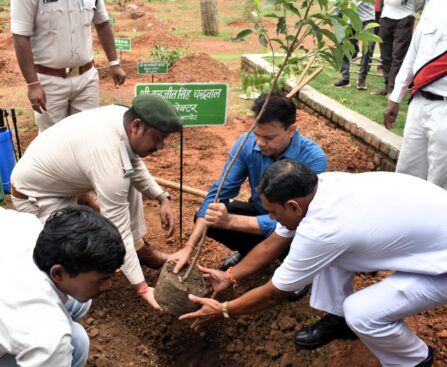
[{"left": 11, "top": 0, "right": 126, "bottom": 132}]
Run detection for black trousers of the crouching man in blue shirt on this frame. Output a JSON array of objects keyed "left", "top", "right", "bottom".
[{"left": 194, "top": 199, "right": 289, "bottom": 259}]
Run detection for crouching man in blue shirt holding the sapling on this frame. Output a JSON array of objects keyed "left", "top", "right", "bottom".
[{"left": 168, "top": 93, "right": 327, "bottom": 278}]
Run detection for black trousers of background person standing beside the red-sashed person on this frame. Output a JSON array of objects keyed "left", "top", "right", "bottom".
[{"left": 379, "top": 15, "right": 414, "bottom": 93}]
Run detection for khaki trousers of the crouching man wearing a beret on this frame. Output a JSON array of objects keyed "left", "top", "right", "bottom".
[{"left": 12, "top": 186, "right": 147, "bottom": 250}]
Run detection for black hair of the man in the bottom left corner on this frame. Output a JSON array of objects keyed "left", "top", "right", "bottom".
[{"left": 33, "top": 207, "right": 126, "bottom": 277}]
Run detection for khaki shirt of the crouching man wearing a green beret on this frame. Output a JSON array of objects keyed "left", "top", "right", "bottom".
[{"left": 11, "top": 105, "right": 163, "bottom": 284}]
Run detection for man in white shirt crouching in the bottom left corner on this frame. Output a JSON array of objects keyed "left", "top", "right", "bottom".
[{"left": 0, "top": 208, "right": 125, "bottom": 367}]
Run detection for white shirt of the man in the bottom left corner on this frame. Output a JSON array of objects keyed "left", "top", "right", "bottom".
[{"left": 0, "top": 208, "right": 73, "bottom": 367}]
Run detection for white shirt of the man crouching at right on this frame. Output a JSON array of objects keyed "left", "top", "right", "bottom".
[{"left": 272, "top": 172, "right": 447, "bottom": 291}]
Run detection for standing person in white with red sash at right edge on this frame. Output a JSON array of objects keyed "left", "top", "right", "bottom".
[{"left": 384, "top": 0, "right": 447, "bottom": 190}]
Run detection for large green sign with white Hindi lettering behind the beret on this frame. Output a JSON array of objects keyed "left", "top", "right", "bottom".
[{"left": 135, "top": 83, "right": 228, "bottom": 126}]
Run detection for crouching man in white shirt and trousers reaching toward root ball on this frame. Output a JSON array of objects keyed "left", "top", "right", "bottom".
[{"left": 180, "top": 160, "right": 447, "bottom": 367}]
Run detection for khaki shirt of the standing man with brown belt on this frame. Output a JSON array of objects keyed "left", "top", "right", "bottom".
[{"left": 11, "top": 0, "right": 109, "bottom": 69}]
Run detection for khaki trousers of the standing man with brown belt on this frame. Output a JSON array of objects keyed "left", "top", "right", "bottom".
[{"left": 34, "top": 67, "right": 99, "bottom": 133}]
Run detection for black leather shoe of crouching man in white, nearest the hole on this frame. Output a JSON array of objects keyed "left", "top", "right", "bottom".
[{"left": 295, "top": 314, "right": 358, "bottom": 349}]
